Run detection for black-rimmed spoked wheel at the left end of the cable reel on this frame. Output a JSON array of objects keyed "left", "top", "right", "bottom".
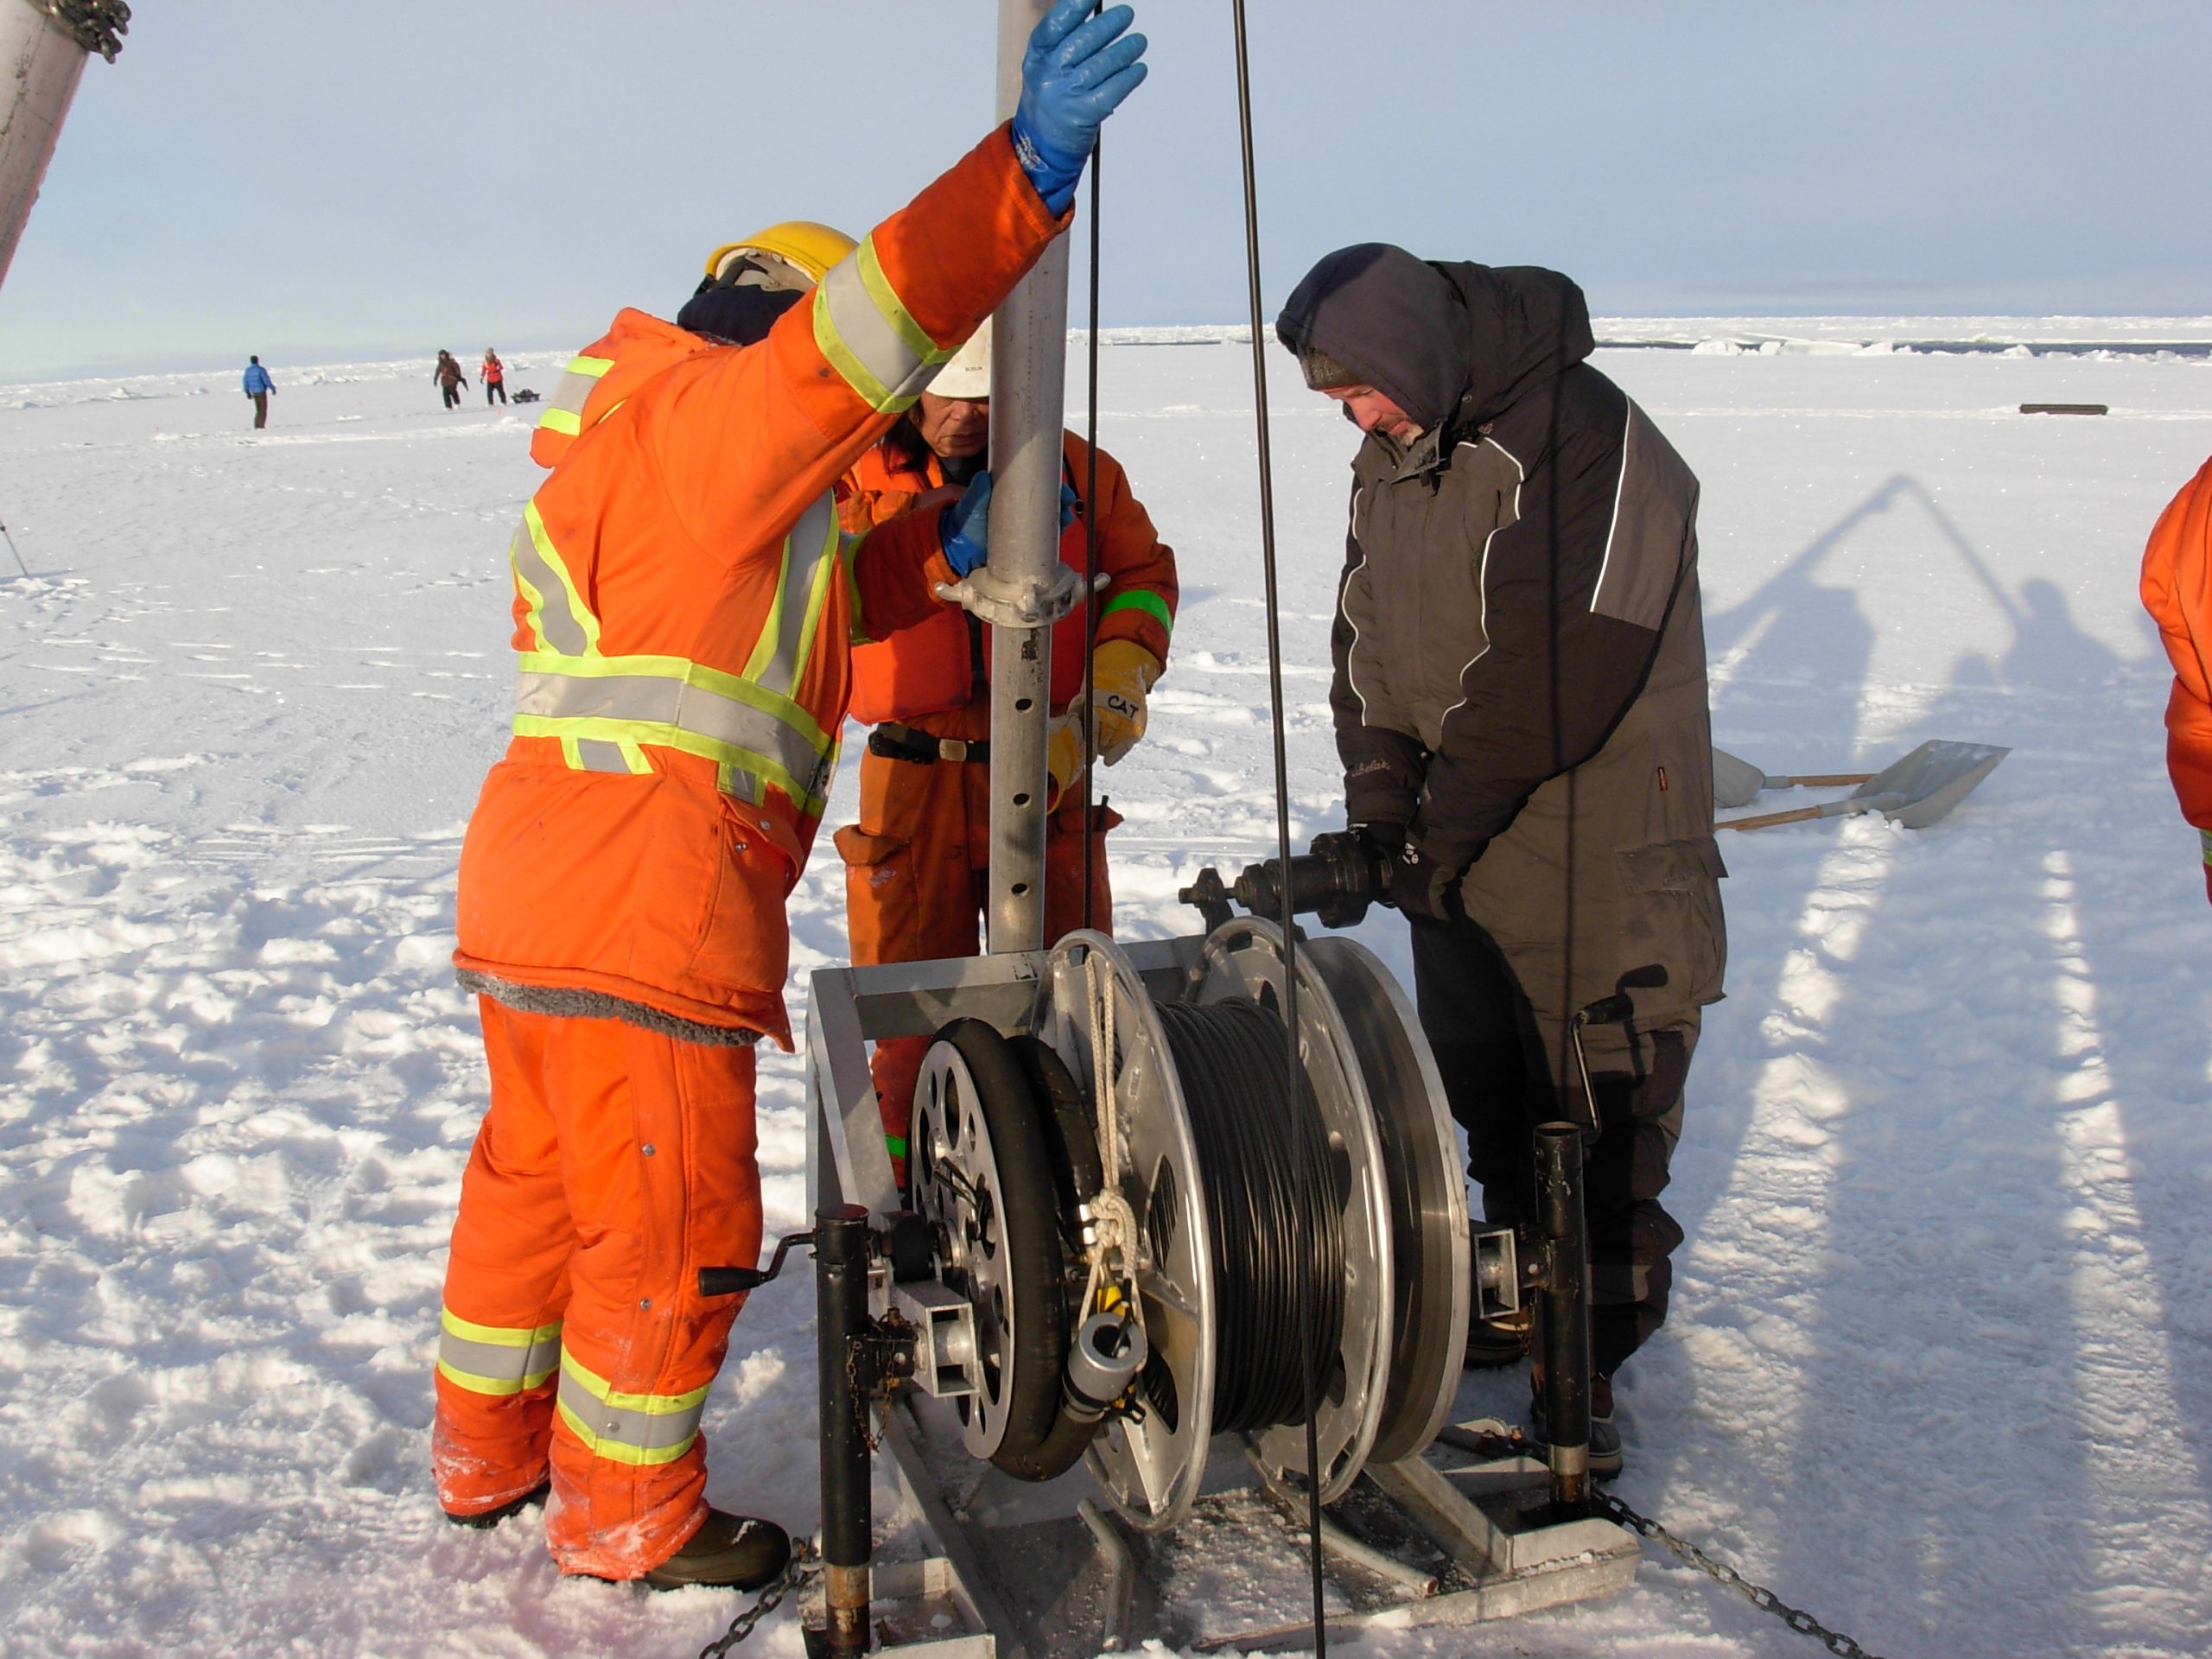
[{"left": 912, "top": 1020, "right": 1068, "bottom": 1473}]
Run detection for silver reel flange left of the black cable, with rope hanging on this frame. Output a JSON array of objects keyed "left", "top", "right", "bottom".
[{"left": 1038, "top": 929, "right": 1217, "bottom": 1533}]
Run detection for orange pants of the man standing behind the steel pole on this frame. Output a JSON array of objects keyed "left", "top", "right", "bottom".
[{"left": 836, "top": 695, "right": 1122, "bottom": 1168}]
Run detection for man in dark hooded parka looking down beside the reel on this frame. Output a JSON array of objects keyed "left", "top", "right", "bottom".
[{"left": 1276, "top": 244, "right": 1726, "bottom": 1473}]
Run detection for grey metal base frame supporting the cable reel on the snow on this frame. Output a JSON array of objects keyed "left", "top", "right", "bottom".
[{"left": 805, "top": 938, "right": 1642, "bottom": 1659}]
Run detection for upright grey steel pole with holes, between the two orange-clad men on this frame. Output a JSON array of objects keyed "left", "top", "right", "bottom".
[{"left": 987, "top": 0, "right": 1068, "bottom": 951}]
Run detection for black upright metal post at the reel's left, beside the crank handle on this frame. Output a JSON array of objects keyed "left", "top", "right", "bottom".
[{"left": 814, "top": 1204, "right": 874, "bottom": 1655}]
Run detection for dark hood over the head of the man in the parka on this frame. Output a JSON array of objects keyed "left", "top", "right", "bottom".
[{"left": 1274, "top": 241, "right": 1597, "bottom": 431}]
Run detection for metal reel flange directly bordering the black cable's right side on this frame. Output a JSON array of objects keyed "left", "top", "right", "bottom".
[{"left": 1192, "top": 916, "right": 1395, "bottom": 1504}]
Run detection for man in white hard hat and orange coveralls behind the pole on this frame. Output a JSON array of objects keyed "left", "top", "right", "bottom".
[{"left": 836, "top": 323, "right": 1177, "bottom": 1184}]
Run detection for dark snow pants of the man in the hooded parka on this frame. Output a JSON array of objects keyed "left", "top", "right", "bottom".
[{"left": 1414, "top": 920, "right": 1697, "bottom": 1376}]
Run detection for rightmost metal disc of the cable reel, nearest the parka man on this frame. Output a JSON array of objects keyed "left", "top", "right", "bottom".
[{"left": 1299, "top": 938, "right": 1473, "bottom": 1462}]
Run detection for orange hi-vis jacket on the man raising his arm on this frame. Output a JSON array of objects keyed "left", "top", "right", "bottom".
[{"left": 454, "top": 126, "right": 1066, "bottom": 1046}]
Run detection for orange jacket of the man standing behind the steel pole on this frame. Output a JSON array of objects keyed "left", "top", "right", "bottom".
[{"left": 838, "top": 431, "right": 1177, "bottom": 726}]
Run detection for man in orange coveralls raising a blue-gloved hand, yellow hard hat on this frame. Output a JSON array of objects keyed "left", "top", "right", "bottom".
[{"left": 431, "top": 0, "right": 1144, "bottom": 1588}]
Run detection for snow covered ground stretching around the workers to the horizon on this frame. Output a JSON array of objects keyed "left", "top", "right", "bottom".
[{"left": 0, "top": 319, "right": 2212, "bottom": 1659}]
